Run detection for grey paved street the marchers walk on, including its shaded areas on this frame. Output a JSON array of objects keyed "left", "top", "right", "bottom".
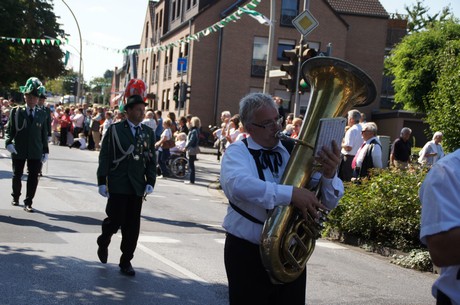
[{"left": 0, "top": 140, "right": 436, "bottom": 305}]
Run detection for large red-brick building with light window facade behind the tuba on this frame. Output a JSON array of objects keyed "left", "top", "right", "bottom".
[{"left": 126, "top": 0, "right": 398, "bottom": 135}]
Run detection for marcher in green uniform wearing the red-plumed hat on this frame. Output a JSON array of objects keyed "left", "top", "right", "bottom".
[{"left": 97, "top": 95, "right": 156, "bottom": 276}]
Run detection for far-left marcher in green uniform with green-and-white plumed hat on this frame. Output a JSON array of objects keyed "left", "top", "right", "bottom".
[{"left": 5, "top": 77, "right": 49, "bottom": 212}]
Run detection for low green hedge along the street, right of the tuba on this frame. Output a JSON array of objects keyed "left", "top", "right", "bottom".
[{"left": 325, "top": 167, "right": 427, "bottom": 251}]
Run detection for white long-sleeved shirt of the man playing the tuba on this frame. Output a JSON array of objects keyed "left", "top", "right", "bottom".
[{"left": 220, "top": 137, "right": 344, "bottom": 244}]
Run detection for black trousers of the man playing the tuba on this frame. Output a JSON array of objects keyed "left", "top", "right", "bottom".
[{"left": 224, "top": 234, "right": 307, "bottom": 305}]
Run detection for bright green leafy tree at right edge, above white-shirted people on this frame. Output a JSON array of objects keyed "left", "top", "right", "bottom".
[{"left": 385, "top": 18, "right": 460, "bottom": 151}]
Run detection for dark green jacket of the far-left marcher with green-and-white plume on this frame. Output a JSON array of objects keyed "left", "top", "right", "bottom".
[{"left": 5, "top": 105, "right": 49, "bottom": 160}]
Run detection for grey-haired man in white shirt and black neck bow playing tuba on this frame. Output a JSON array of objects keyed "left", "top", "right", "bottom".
[{"left": 220, "top": 93, "right": 344, "bottom": 305}]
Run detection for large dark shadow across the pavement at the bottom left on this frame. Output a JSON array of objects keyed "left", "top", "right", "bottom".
[{"left": 0, "top": 246, "right": 227, "bottom": 305}]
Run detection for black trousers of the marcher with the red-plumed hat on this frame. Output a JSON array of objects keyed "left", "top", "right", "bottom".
[{"left": 97, "top": 193, "right": 142, "bottom": 267}]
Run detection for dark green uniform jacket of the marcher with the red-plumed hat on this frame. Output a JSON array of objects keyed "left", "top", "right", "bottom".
[{"left": 97, "top": 120, "right": 156, "bottom": 196}]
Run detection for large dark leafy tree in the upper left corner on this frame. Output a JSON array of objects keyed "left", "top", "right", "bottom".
[{"left": 0, "top": 0, "right": 65, "bottom": 88}]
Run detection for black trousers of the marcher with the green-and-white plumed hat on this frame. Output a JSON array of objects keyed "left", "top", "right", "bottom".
[{"left": 11, "top": 159, "right": 42, "bottom": 206}]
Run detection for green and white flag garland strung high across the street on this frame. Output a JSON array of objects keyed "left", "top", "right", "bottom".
[{"left": 0, "top": 0, "right": 266, "bottom": 55}]
